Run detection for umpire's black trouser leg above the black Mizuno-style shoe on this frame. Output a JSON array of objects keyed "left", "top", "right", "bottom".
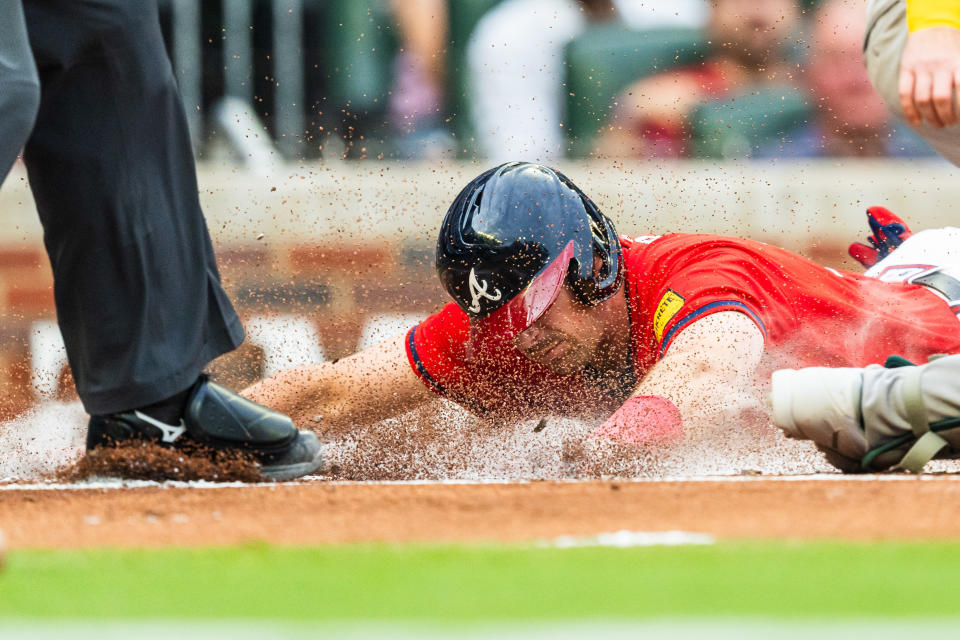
[{"left": 24, "top": 0, "right": 243, "bottom": 413}]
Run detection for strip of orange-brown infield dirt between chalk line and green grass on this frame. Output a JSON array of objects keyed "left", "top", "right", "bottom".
[{"left": 0, "top": 475, "right": 960, "bottom": 549}]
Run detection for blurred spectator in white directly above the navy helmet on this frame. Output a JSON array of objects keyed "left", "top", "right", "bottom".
[{"left": 467, "top": 0, "right": 705, "bottom": 162}]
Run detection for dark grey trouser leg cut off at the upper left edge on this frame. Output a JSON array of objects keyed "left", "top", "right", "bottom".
[{"left": 0, "top": 0, "right": 40, "bottom": 184}]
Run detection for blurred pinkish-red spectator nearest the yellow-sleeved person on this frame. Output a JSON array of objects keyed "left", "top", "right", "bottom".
[{"left": 755, "top": 0, "right": 933, "bottom": 157}]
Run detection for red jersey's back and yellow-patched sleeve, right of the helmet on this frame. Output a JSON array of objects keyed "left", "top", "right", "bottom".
[{"left": 625, "top": 234, "right": 960, "bottom": 376}]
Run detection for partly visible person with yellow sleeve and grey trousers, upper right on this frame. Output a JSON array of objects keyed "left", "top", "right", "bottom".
[{"left": 863, "top": 0, "right": 960, "bottom": 166}]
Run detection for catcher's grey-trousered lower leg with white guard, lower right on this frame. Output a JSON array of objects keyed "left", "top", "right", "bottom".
[{"left": 771, "top": 355, "right": 960, "bottom": 473}]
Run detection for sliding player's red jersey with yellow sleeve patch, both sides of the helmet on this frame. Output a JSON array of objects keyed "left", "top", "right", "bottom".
[{"left": 407, "top": 233, "right": 960, "bottom": 414}]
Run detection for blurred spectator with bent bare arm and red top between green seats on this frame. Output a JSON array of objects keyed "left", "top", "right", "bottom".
[{"left": 597, "top": 0, "right": 800, "bottom": 158}]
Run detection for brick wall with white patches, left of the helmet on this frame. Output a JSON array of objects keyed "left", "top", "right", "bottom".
[{"left": 0, "top": 239, "right": 445, "bottom": 421}]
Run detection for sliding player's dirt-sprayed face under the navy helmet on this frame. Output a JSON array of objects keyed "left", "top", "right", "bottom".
[{"left": 513, "top": 286, "right": 603, "bottom": 375}]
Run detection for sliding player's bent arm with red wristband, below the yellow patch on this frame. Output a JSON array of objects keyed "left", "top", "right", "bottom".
[{"left": 597, "top": 311, "right": 764, "bottom": 444}]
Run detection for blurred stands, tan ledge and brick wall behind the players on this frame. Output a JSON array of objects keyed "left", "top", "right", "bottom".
[{"left": 0, "top": 0, "right": 960, "bottom": 420}]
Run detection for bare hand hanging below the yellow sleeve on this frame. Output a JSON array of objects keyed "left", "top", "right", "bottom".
[{"left": 900, "top": 27, "right": 960, "bottom": 128}]
